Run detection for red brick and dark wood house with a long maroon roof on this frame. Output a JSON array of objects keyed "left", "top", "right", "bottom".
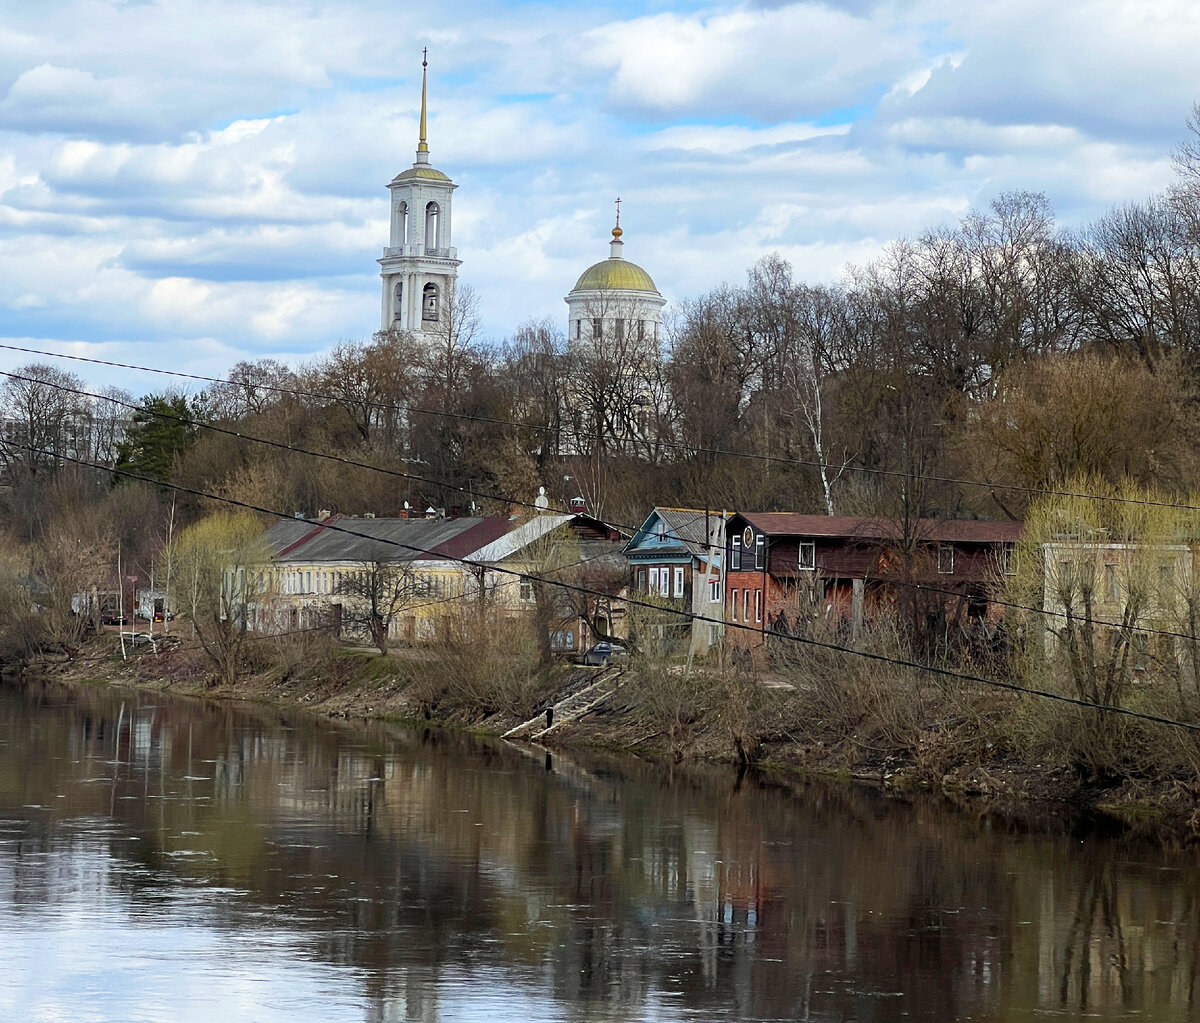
[{"left": 725, "top": 512, "right": 1024, "bottom": 648}]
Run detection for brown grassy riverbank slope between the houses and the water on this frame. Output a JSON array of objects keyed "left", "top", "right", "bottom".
[{"left": 18, "top": 636, "right": 1200, "bottom": 843}]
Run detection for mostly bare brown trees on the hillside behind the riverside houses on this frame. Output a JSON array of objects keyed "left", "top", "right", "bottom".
[{"left": 7, "top": 125, "right": 1200, "bottom": 554}]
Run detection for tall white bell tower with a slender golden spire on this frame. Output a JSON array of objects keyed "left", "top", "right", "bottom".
[{"left": 379, "top": 50, "right": 461, "bottom": 337}]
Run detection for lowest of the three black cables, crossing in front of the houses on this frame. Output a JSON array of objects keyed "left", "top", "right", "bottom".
[{"left": 4, "top": 441, "right": 1200, "bottom": 732}]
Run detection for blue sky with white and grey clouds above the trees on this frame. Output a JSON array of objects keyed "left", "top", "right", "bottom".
[{"left": 0, "top": 0, "right": 1200, "bottom": 395}]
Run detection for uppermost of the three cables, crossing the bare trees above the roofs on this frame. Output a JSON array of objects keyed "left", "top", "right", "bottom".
[{"left": 0, "top": 343, "right": 1200, "bottom": 512}]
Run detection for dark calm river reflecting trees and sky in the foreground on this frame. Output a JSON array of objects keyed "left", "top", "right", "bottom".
[{"left": 0, "top": 686, "right": 1200, "bottom": 1023}]
